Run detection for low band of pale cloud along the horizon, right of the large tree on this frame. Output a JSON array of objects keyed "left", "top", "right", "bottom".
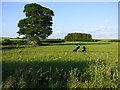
[{"left": 49, "top": 25, "right": 118, "bottom": 39}]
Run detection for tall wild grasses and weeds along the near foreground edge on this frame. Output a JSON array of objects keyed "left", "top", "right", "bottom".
[{"left": 2, "top": 60, "right": 120, "bottom": 90}]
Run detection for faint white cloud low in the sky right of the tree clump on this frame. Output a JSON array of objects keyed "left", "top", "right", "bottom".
[{"left": 87, "top": 25, "right": 118, "bottom": 38}]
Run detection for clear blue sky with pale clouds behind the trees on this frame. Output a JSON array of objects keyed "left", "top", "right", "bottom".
[{"left": 0, "top": 2, "right": 118, "bottom": 39}]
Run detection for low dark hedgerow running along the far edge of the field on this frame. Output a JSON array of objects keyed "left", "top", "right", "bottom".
[{"left": 0, "top": 37, "right": 120, "bottom": 45}]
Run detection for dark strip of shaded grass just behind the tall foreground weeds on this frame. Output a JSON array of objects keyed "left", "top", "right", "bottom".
[{"left": 2, "top": 60, "right": 93, "bottom": 80}]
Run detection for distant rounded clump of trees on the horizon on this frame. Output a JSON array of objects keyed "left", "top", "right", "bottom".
[{"left": 64, "top": 33, "right": 92, "bottom": 41}]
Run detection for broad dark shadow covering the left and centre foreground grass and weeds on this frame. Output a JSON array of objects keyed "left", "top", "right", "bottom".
[{"left": 2, "top": 60, "right": 93, "bottom": 88}]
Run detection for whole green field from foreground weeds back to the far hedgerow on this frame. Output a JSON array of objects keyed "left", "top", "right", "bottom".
[{"left": 2, "top": 42, "right": 120, "bottom": 90}]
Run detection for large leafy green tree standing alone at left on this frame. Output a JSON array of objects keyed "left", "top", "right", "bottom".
[{"left": 17, "top": 3, "right": 54, "bottom": 45}]
